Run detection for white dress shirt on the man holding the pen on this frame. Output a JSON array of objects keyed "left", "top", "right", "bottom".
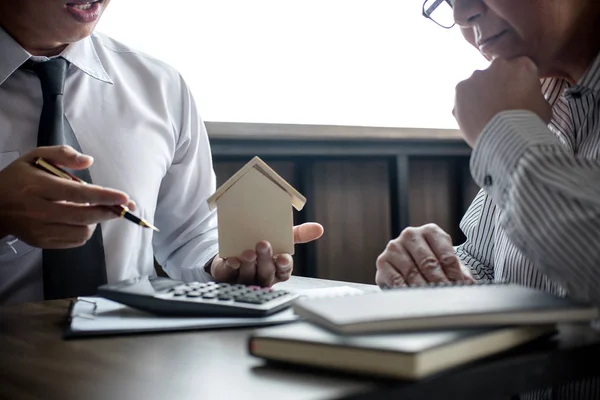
[{"left": 0, "top": 28, "right": 218, "bottom": 304}]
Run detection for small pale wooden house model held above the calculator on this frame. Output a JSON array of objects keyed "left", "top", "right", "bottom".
[{"left": 208, "top": 157, "right": 306, "bottom": 258}]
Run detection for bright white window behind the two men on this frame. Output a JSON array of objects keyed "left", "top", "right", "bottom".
[{"left": 98, "top": 0, "right": 487, "bottom": 128}]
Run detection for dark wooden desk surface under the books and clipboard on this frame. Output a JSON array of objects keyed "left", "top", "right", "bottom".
[{"left": 0, "top": 277, "right": 600, "bottom": 400}]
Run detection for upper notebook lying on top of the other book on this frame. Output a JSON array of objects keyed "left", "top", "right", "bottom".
[{"left": 292, "top": 283, "right": 599, "bottom": 334}]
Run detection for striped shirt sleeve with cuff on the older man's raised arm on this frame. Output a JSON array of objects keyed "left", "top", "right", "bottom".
[{"left": 471, "top": 111, "right": 600, "bottom": 304}]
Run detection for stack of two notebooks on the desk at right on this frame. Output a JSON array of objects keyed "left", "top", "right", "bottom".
[{"left": 248, "top": 283, "right": 599, "bottom": 380}]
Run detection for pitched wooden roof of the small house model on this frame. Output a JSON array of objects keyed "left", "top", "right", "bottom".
[{"left": 207, "top": 157, "right": 306, "bottom": 211}]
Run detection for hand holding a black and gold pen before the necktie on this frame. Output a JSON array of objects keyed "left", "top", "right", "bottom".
[{"left": 0, "top": 146, "right": 135, "bottom": 249}]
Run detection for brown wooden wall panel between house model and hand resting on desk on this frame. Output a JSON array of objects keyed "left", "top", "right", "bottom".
[{"left": 309, "top": 160, "right": 391, "bottom": 283}]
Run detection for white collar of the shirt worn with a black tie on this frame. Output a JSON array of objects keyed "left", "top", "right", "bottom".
[{"left": 0, "top": 27, "right": 113, "bottom": 85}]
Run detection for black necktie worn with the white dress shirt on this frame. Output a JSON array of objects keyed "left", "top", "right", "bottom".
[{"left": 22, "top": 58, "right": 106, "bottom": 300}]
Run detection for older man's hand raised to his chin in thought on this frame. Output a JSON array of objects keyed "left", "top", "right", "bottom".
[{"left": 453, "top": 57, "right": 552, "bottom": 147}]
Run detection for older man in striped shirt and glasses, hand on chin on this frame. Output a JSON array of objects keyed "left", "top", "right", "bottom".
[{"left": 376, "top": 0, "right": 600, "bottom": 399}]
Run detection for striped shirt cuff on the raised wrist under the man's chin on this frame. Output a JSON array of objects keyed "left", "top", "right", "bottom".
[{"left": 470, "top": 110, "right": 563, "bottom": 208}]
